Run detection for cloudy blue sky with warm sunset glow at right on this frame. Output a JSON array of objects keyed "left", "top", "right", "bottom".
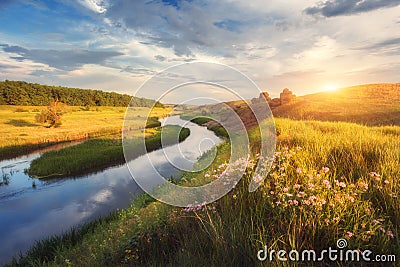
[{"left": 0, "top": 0, "right": 400, "bottom": 101}]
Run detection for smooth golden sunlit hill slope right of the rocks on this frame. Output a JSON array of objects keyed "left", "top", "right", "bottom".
[{"left": 272, "top": 83, "right": 400, "bottom": 125}]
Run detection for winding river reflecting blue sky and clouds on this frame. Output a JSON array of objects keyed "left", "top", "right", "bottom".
[{"left": 0, "top": 116, "right": 222, "bottom": 265}]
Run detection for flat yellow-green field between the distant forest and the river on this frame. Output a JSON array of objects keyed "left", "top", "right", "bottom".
[{"left": 0, "top": 106, "right": 171, "bottom": 159}]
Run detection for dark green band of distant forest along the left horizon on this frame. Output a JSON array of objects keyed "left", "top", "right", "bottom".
[{"left": 0, "top": 80, "right": 163, "bottom": 107}]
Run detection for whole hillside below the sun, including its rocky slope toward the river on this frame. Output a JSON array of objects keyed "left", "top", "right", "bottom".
[{"left": 194, "top": 83, "right": 400, "bottom": 129}]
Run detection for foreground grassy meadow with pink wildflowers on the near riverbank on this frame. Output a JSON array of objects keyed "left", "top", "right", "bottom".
[{"left": 8, "top": 119, "right": 400, "bottom": 266}]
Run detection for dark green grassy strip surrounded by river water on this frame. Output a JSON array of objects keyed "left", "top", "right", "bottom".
[{"left": 27, "top": 125, "right": 190, "bottom": 178}]
